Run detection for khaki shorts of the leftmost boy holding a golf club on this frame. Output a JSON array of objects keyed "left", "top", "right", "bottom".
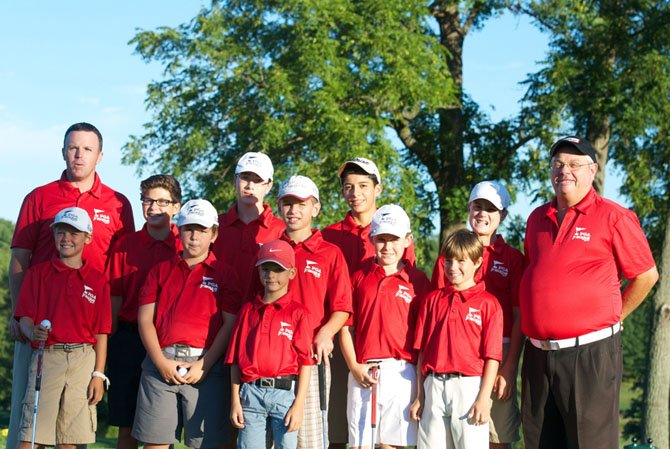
[{"left": 19, "top": 345, "right": 97, "bottom": 446}]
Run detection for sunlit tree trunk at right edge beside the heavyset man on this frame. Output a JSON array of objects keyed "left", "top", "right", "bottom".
[{"left": 643, "top": 213, "right": 670, "bottom": 449}]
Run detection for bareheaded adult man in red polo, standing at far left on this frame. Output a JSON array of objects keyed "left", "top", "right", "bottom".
[{"left": 7, "top": 123, "right": 135, "bottom": 447}]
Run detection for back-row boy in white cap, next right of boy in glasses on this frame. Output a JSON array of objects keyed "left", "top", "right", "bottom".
[{"left": 212, "top": 152, "right": 284, "bottom": 300}]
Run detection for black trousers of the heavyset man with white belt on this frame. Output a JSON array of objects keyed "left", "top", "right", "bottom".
[{"left": 521, "top": 332, "right": 623, "bottom": 449}]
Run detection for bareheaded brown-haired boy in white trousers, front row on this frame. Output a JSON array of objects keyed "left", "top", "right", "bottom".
[{"left": 410, "top": 229, "right": 503, "bottom": 449}]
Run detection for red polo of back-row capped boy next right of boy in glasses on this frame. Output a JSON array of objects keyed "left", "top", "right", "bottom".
[{"left": 212, "top": 204, "right": 286, "bottom": 300}]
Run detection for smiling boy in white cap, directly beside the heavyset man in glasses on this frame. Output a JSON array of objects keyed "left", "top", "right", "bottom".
[{"left": 431, "top": 181, "right": 525, "bottom": 449}]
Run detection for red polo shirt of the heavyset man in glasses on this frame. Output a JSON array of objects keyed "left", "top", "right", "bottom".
[{"left": 520, "top": 189, "right": 655, "bottom": 339}]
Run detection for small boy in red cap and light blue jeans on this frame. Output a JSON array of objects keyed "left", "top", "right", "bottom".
[{"left": 226, "top": 240, "right": 313, "bottom": 448}]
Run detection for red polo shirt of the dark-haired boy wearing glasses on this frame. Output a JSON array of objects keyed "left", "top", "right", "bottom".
[{"left": 107, "top": 224, "right": 181, "bottom": 323}]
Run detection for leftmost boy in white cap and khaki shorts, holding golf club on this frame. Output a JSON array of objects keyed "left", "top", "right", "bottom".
[{"left": 14, "top": 207, "right": 112, "bottom": 449}]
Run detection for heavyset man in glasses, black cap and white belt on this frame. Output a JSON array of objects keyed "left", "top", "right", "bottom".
[{"left": 520, "top": 137, "right": 658, "bottom": 449}]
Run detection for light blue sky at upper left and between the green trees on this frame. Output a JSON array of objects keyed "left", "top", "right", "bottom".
[{"left": 0, "top": 0, "right": 618, "bottom": 228}]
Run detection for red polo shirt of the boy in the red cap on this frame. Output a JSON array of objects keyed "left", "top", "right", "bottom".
[{"left": 225, "top": 292, "right": 314, "bottom": 382}]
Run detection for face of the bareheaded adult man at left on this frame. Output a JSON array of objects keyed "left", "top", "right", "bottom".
[{"left": 63, "top": 131, "right": 102, "bottom": 182}]
